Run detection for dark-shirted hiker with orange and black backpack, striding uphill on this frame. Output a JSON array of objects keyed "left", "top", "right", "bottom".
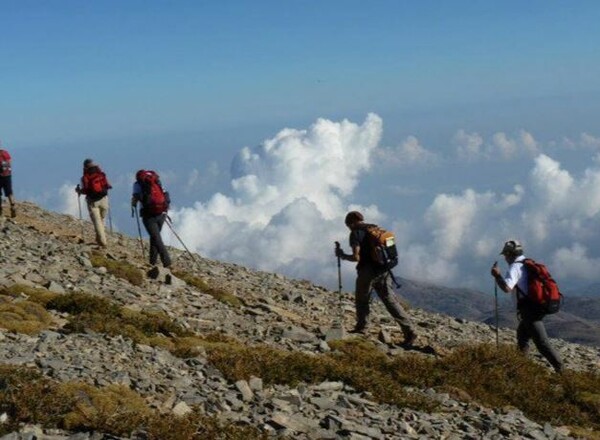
[{"left": 335, "top": 211, "right": 417, "bottom": 347}]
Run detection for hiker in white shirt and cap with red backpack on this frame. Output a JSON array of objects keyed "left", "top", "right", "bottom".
[{"left": 491, "top": 240, "right": 563, "bottom": 372}]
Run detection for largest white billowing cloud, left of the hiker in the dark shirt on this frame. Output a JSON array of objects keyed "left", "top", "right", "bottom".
[{"left": 172, "top": 114, "right": 382, "bottom": 280}]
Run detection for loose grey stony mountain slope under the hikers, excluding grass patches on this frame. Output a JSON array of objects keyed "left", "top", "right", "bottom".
[{"left": 0, "top": 202, "right": 600, "bottom": 440}]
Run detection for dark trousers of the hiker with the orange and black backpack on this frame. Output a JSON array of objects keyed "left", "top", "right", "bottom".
[{"left": 355, "top": 265, "right": 415, "bottom": 336}]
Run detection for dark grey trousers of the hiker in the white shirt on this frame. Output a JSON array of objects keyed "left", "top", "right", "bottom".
[{"left": 517, "top": 304, "right": 562, "bottom": 371}]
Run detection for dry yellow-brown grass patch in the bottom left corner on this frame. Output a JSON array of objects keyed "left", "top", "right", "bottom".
[{"left": 0, "top": 365, "right": 267, "bottom": 440}]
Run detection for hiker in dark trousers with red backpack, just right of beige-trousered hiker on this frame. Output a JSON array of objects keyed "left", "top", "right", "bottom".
[{"left": 131, "top": 170, "right": 171, "bottom": 268}]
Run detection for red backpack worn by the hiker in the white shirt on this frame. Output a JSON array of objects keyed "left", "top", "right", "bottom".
[{"left": 521, "top": 258, "right": 563, "bottom": 315}]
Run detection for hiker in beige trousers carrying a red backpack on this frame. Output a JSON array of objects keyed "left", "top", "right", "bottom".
[{"left": 75, "top": 159, "right": 112, "bottom": 247}]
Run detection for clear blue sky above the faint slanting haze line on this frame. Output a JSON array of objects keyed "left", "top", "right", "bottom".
[{"left": 0, "top": 1, "right": 600, "bottom": 145}]
